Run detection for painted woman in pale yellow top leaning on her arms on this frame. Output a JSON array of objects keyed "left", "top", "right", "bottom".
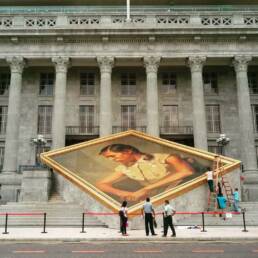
[{"left": 96, "top": 144, "right": 202, "bottom": 201}]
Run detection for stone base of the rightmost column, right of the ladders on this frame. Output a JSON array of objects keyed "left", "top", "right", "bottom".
[{"left": 242, "top": 171, "right": 258, "bottom": 202}]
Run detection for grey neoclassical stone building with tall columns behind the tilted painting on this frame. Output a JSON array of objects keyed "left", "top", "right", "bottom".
[{"left": 0, "top": 0, "right": 258, "bottom": 202}]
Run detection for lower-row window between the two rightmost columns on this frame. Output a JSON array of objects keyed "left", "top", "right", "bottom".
[{"left": 206, "top": 105, "right": 220, "bottom": 133}]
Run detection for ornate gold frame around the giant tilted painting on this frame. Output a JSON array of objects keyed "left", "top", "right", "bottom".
[{"left": 40, "top": 130, "right": 241, "bottom": 214}]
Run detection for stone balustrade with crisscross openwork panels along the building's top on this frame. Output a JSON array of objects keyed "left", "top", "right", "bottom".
[{"left": 0, "top": 10, "right": 258, "bottom": 30}]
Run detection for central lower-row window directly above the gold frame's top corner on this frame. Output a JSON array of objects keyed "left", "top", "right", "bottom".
[{"left": 121, "top": 105, "right": 136, "bottom": 129}]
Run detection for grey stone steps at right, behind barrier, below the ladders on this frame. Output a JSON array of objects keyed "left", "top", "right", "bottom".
[{"left": 175, "top": 202, "right": 258, "bottom": 227}]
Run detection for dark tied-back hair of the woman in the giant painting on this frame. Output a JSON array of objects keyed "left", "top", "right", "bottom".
[{"left": 99, "top": 143, "right": 154, "bottom": 160}]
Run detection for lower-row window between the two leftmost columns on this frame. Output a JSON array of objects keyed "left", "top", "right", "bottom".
[{"left": 38, "top": 106, "right": 52, "bottom": 135}]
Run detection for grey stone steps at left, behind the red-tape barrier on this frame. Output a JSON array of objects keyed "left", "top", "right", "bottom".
[{"left": 0, "top": 202, "right": 107, "bottom": 227}]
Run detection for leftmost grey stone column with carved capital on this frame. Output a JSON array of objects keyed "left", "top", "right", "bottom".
[{"left": 3, "top": 57, "right": 25, "bottom": 172}]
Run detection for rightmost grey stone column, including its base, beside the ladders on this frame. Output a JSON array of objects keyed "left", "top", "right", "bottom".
[{"left": 233, "top": 56, "right": 258, "bottom": 201}]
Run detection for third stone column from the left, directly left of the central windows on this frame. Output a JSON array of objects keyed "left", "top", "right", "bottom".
[{"left": 97, "top": 56, "right": 114, "bottom": 137}]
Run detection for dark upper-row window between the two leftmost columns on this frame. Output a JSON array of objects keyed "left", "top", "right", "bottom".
[{"left": 39, "top": 73, "right": 55, "bottom": 96}]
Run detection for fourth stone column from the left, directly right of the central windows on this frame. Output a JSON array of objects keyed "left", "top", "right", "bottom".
[{"left": 144, "top": 56, "right": 160, "bottom": 137}]
